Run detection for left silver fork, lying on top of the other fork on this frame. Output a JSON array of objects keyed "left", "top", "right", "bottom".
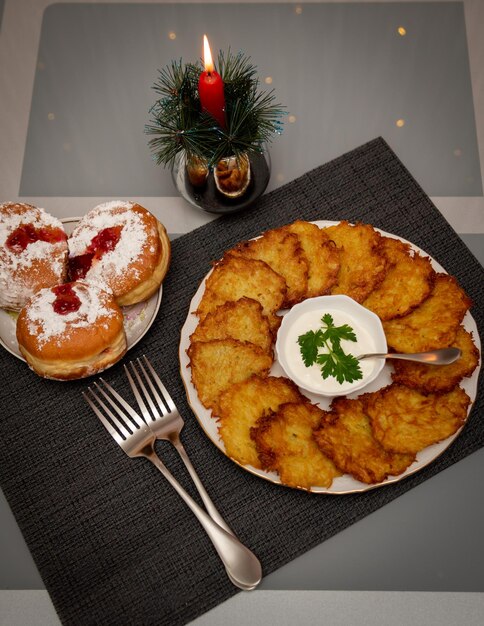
[{"left": 82, "top": 378, "right": 262, "bottom": 591}]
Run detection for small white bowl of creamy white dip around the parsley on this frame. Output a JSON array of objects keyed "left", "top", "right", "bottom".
[{"left": 276, "top": 295, "right": 387, "bottom": 397}]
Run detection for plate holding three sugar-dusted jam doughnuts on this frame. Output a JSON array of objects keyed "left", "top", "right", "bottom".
[{"left": 0, "top": 201, "right": 171, "bottom": 380}]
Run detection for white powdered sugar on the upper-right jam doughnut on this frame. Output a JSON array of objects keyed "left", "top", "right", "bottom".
[{"left": 68, "top": 201, "right": 147, "bottom": 290}]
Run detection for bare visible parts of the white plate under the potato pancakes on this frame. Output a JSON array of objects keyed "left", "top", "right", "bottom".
[{"left": 179, "top": 220, "right": 481, "bottom": 494}]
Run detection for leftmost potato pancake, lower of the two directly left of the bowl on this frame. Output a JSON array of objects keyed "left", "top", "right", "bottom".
[{"left": 187, "top": 339, "right": 272, "bottom": 415}]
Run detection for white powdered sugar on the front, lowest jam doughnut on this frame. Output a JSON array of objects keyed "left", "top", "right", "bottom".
[{"left": 26, "top": 283, "right": 116, "bottom": 345}]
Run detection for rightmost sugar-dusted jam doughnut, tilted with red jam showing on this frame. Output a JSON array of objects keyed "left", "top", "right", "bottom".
[{"left": 68, "top": 201, "right": 170, "bottom": 306}]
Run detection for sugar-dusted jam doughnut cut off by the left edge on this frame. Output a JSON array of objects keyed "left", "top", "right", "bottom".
[{"left": 0, "top": 202, "right": 67, "bottom": 311}]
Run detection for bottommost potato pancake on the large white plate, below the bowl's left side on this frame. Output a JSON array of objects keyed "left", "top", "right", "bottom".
[{"left": 250, "top": 402, "right": 341, "bottom": 489}]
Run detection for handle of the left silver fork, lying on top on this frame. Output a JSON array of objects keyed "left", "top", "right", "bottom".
[{"left": 144, "top": 450, "right": 262, "bottom": 591}]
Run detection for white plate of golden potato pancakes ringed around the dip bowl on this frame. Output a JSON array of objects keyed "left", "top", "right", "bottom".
[{"left": 179, "top": 220, "right": 481, "bottom": 494}]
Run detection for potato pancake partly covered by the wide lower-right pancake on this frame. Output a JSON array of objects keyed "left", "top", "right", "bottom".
[{"left": 314, "top": 397, "right": 415, "bottom": 484}]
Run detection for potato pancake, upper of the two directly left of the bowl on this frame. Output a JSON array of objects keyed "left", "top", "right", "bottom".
[{"left": 190, "top": 298, "right": 273, "bottom": 355}]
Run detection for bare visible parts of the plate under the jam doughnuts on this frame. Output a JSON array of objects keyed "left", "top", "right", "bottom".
[{"left": 0, "top": 217, "right": 163, "bottom": 361}]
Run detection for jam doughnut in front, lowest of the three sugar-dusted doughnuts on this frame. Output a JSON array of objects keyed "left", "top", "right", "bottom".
[{"left": 17, "top": 282, "right": 127, "bottom": 380}]
